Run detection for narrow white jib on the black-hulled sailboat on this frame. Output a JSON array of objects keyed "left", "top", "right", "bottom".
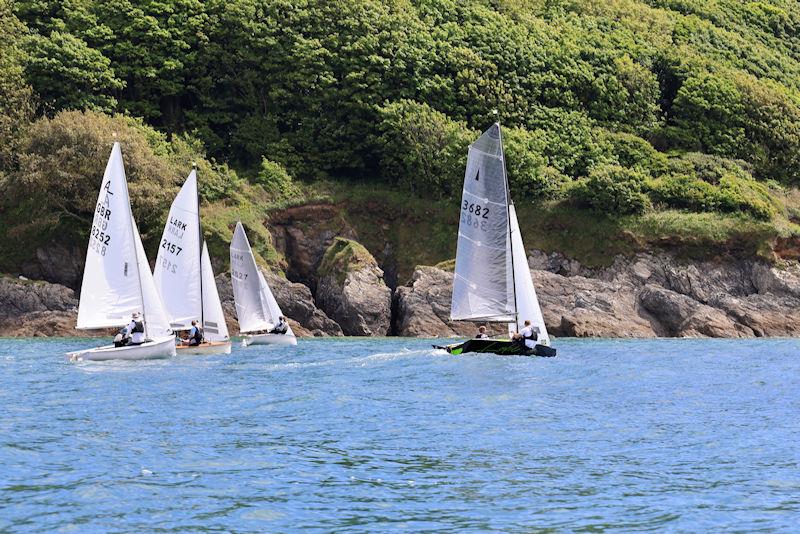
[{"left": 508, "top": 204, "right": 550, "bottom": 345}]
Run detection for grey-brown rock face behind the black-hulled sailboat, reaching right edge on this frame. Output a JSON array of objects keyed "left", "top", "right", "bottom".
[{"left": 395, "top": 251, "right": 800, "bottom": 337}]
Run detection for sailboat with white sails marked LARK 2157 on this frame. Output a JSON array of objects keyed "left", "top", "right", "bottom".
[{"left": 153, "top": 170, "right": 231, "bottom": 354}]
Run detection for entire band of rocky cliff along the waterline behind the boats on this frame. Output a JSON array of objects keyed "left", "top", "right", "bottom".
[{"left": 0, "top": 249, "right": 800, "bottom": 338}]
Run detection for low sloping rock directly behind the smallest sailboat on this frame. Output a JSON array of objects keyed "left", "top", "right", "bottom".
[{"left": 216, "top": 273, "right": 342, "bottom": 337}]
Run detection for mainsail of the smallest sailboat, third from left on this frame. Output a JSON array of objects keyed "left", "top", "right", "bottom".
[{"left": 231, "top": 222, "right": 274, "bottom": 332}]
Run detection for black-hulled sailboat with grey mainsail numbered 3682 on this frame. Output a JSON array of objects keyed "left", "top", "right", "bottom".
[{"left": 437, "top": 123, "right": 556, "bottom": 356}]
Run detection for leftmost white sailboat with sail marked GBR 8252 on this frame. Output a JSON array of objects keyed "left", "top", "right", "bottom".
[{"left": 67, "top": 142, "right": 175, "bottom": 361}]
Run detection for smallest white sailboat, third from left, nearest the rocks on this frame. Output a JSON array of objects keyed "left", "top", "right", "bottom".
[{"left": 231, "top": 222, "right": 297, "bottom": 347}]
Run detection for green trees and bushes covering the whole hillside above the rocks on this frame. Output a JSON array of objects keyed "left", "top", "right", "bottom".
[{"left": 0, "top": 0, "right": 800, "bottom": 276}]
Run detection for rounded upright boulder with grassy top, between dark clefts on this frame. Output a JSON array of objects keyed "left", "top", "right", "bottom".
[{"left": 317, "top": 237, "right": 392, "bottom": 336}]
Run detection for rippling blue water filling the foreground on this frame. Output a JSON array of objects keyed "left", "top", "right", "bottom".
[{"left": 0, "top": 339, "right": 800, "bottom": 532}]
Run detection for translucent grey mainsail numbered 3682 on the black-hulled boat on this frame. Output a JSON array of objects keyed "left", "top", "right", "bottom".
[{"left": 450, "top": 123, "right": 516, "bottom": 322}]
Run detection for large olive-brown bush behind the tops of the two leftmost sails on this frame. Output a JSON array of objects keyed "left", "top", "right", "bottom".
[{"left": 0, "top": 111, "right": 236, "bottom": 250}]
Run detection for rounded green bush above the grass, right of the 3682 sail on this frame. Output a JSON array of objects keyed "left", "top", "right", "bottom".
[{"left": 571, "top": 165, "right": 650, "bottom": 217}]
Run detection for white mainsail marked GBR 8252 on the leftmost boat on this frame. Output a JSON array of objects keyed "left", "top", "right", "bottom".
[{"left": 78, "top": 143, "right": 149, "bottom": 329}]
